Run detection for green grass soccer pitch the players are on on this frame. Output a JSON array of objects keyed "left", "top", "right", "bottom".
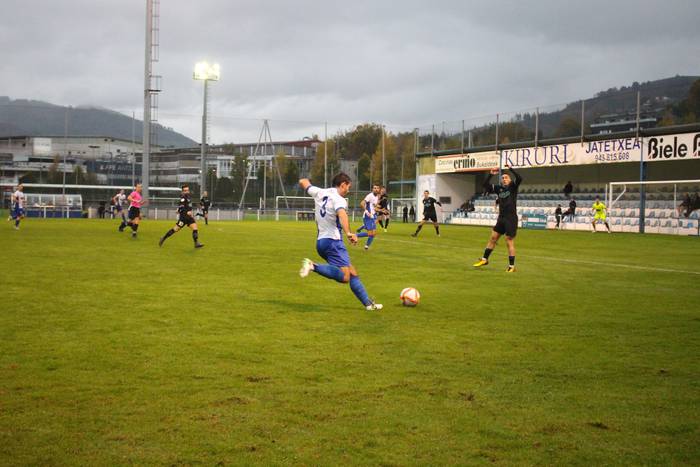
[{"left": 0, "top": 219, "right": 700, "bottom": 465}]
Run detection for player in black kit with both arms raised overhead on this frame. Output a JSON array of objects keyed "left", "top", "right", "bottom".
[{"left": 474, "top": 166, "right": 523, "bottom": 272}]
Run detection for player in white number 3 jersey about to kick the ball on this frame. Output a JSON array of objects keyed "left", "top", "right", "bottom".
[{"left": 299, "top": 172, "right": 382, "bottom": 311}]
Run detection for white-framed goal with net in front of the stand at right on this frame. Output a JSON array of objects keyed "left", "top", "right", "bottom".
[{"left": 605, "top": 180, "right": 700, "bottom": 235}]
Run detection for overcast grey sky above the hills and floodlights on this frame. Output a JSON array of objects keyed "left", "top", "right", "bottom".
[{"left": 0, "top": 0, "right": 700, "bottom": 143}]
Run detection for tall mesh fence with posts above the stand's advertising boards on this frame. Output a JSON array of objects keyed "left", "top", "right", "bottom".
[{"left": 417, "top": 83, "right": 700, "bottom": 154}]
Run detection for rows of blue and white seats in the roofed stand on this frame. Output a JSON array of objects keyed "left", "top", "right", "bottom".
[{"left": 445, "top": 185, "right": 700, "bottom": 235}]
